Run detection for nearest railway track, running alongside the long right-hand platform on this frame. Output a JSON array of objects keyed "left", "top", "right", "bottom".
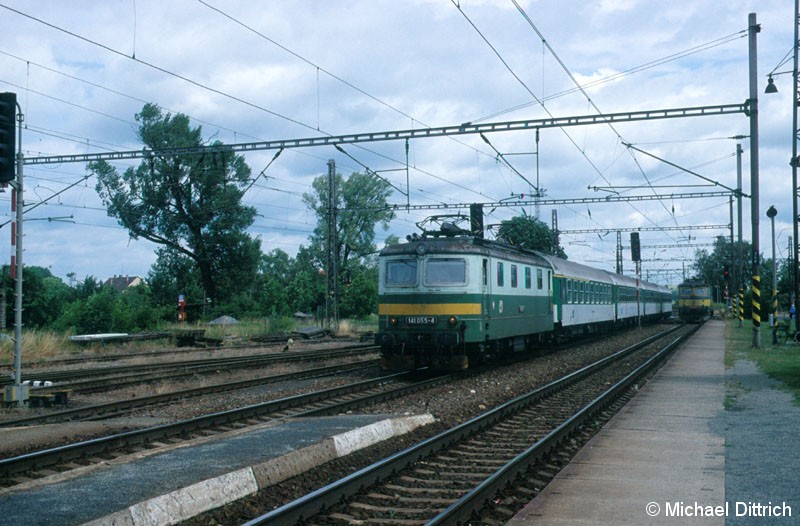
[{"left": 242, "top": 327, "right": 697, "bottom": 526}]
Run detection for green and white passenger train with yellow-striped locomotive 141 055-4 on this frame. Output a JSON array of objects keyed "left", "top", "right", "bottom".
[{"left": 375, "top": 216, "right": 672, "bottom": 370}]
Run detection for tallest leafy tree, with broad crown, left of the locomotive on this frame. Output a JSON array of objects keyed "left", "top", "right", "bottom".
[{"left": 89, "top": 104, "right": 260, "bottom": 301}]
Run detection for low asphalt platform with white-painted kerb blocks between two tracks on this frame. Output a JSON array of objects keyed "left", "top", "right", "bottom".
[{"left": 0, "top": 415, "right": 433, "bottom": 526}]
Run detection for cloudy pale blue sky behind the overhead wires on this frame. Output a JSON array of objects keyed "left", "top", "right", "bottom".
[{"left": 0, "top": 0, "right": 794, "bottom": 285}]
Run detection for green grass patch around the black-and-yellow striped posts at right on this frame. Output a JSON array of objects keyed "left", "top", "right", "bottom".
[{"left": 725, "top": 319, "right": 800, "bottom": 407}]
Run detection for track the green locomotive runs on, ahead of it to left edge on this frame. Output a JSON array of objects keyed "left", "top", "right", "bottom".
[{"left": 0, "top": 373, "right": 455, "bottom": 487}]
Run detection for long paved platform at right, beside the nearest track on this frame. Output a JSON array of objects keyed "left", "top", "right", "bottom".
[{"left": 507, "top": 321, "right": 734, "bottom": 526}]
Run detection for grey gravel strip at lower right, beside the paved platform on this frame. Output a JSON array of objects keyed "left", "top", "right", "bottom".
[{"left": 720, "top": 356, "right": 800, "bottom": 526}]
